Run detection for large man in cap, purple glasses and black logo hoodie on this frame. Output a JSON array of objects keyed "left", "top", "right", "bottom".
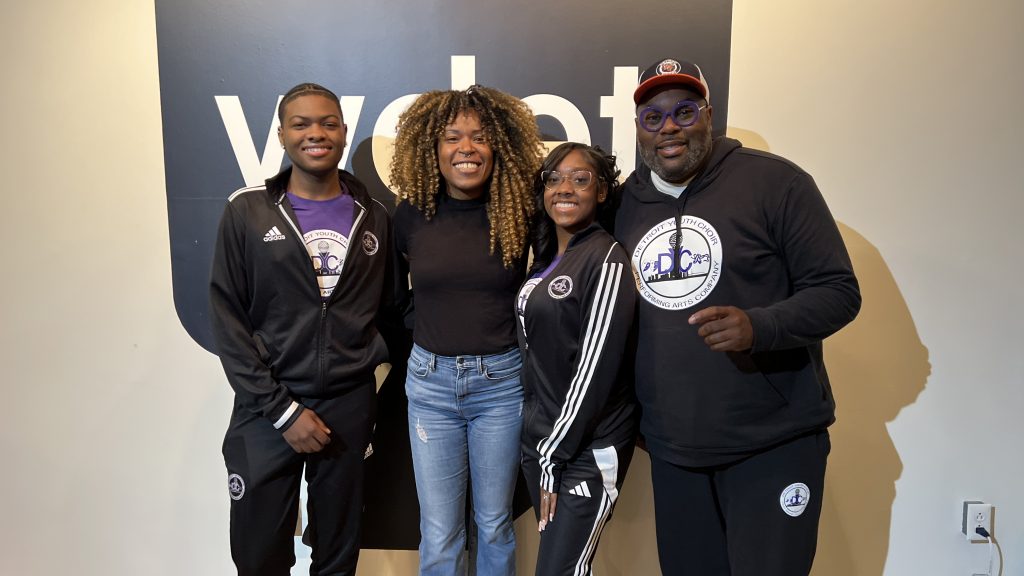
[{"left": 615, "top": 58, "right": 860, "bottom": 576}]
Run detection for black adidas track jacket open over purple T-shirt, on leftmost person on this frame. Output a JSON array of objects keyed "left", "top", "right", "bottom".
[{"left": 210, "top": 168, "right": 393, "bottom": 429}]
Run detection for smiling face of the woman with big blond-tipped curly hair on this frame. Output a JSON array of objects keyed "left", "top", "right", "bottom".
[{"left": 437, "top": 110, "right": 495, "bottom": 200}]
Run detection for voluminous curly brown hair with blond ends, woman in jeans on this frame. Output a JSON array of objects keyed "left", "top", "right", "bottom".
[{"left": 390, "top": 86, "right": 544, "bottom": 268}]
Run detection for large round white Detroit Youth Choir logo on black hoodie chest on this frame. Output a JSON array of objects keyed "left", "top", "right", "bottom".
[{"left": 633, "top": 216, "right": 722, "bottom": 310}]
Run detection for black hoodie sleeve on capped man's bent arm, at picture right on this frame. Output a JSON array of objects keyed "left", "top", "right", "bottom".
[{"left": 745, "top": 172, "right": 860, "bottom": 353}]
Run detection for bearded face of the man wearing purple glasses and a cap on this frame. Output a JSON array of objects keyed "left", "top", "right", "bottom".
[{"left": 637, "top": 87, "right": 712, "bottom": 184}]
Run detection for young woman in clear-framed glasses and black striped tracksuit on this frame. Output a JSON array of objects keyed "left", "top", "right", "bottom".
[{"left": 516, "top": 142, "right": 637, "bottom": 575}]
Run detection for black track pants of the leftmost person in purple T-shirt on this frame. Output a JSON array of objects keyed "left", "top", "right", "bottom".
[{"left": 223, "top": 383, "right": 377, "bottom": 576}]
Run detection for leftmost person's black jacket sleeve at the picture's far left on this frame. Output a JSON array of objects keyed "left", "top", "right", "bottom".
[{"left": 210, "top": 202, "right": 302, "bottom": 429}]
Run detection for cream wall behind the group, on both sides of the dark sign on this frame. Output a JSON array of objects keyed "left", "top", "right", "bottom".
[{"left": 0, "top": 0, "right": 1024, "bottom": 576}]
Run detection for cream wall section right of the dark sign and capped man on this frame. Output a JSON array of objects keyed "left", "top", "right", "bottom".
[{"left": 729, "top": 0, "right": 1024, "bottom": 576}]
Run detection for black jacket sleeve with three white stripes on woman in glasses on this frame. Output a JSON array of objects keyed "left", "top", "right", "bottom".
[{"left": 537, "top": 244, "right": 636, "bottom": 494}]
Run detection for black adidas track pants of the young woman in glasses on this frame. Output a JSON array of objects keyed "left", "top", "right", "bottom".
[{"left": 522, "top": 437, "right": 635, "bottom": 576}]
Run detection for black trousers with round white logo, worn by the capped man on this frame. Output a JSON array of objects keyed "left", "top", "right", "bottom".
[{"left": 650, "top": 430, "right": 830, "bottom": 576}]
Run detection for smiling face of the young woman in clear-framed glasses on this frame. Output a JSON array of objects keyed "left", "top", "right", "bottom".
[{"left": 544, "top": 150, "right": 608, "bottom": 237}]
